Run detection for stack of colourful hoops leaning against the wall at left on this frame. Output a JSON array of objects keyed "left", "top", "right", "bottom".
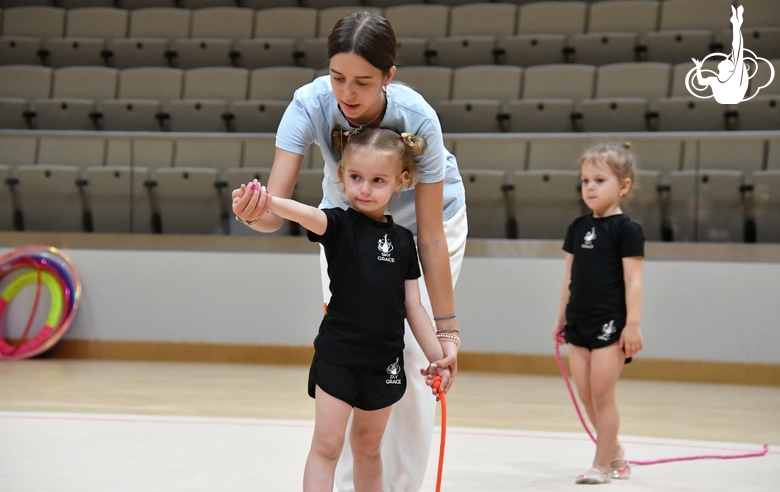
[{"left": 0, "top": 246, "right": 81, "bottom": 359}]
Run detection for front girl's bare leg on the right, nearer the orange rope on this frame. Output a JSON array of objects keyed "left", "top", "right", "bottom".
[{"left": 350, "top": 407, "right": 393, "bottom": 492}]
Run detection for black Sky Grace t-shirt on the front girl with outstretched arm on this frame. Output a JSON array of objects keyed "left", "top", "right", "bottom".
[{"left": 308, "top": 208, "right": 420, "bottom": 367}]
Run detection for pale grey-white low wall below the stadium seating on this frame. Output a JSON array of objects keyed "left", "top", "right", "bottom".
[{"left": 0, "top": 243, "right": 780, "bottom": 364}]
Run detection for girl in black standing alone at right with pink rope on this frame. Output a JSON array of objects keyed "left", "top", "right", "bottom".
[{"left": 553, "top": 144, "right": 644, "bottom": 484}]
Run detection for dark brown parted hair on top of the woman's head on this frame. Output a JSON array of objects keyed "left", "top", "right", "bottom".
[{"left": 328, "top": 11, "right": 398, "bottom": 73}]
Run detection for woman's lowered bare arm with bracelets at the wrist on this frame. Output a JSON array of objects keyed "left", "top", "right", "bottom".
[{"left": 414, "top": 181, "right": 458, "bottom": 370}]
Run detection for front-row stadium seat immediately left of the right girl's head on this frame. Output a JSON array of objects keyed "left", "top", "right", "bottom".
[{"left": 512, "top": 170, "right": 583, "bottom": 240}]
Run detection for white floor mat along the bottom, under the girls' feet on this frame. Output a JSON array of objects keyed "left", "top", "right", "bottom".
[{"left": 0, "top": 412, "right": 780, "bottom": 492}]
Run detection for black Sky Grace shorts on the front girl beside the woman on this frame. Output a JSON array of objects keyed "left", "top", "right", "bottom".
[{"left": 309, "top": 352, "right": 406, "bottom": 411}]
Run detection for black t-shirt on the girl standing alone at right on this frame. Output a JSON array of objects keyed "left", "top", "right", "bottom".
[{"left": 563, "top": 214, "right": 645, "bottom": 323}]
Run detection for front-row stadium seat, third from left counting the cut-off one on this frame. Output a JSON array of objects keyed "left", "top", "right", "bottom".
[{"left": 85, "top": 166, "right": 152, "bottom": 234}]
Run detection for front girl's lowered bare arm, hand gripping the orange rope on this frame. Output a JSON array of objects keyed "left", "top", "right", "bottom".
[{"left": 404, "top": 279, "right": 457, "bottom": 395}]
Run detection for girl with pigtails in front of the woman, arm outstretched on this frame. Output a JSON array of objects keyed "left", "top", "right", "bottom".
[{"left": 234, "top": 128, "right": 460, "bottom": 492}]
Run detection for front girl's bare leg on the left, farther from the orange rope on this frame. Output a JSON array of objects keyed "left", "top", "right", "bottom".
[{"left": 303, "top": 386, "right": 354, "bottom": 492}]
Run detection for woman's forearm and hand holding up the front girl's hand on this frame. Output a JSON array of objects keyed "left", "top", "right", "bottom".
[{"left": 232, "top": 148, "right": 303, "bottom": 232}]
